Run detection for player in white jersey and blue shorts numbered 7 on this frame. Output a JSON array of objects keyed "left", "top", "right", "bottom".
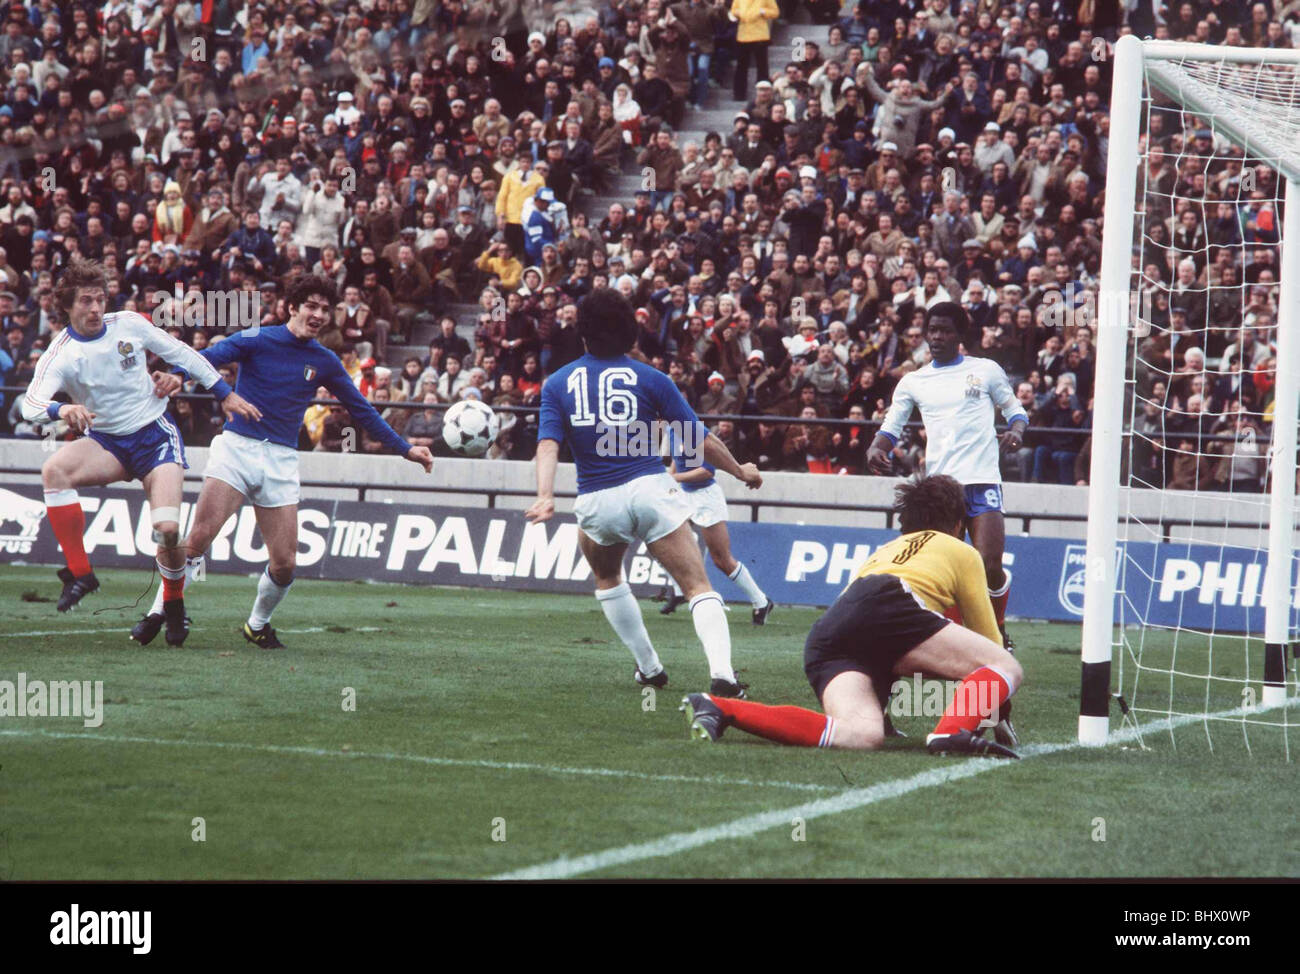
[{"left": 22, "top": 259, "right": 261, "bottom": 637}]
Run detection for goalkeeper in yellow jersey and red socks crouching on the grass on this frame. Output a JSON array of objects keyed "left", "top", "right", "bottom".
[{"left": 681, "top": 476, "right": 1024, "bottom": 758}]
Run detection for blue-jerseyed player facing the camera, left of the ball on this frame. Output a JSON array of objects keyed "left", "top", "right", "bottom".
[{"left": 131, "top": 277, "right": 433, "bottom": 649}]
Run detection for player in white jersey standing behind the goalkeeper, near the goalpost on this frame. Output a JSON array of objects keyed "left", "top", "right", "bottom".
[{"left": 867, "top": 302, "right": 1030, "bottom": 746}]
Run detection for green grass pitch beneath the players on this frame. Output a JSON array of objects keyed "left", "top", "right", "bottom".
[{"left": 0, "top": 567, "right": 1300, "bottom": 879}]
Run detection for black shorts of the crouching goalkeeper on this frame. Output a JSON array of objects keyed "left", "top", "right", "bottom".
[{"left": 803, "top": 575, "right": 950, "bottom": 706}]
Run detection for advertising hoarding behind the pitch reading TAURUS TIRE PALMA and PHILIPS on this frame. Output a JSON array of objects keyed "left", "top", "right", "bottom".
[{"left": 0, "top": 485, "right": 1295, "bottom": 633}]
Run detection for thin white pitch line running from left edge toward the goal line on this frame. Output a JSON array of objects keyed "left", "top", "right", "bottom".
[{"left": 0, "top": 731, "right": 837, "bottom": 792}]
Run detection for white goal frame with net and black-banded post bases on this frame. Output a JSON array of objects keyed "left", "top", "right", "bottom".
[{"left": 1079, "top": 36, "right": 1300, "bottom": 757}]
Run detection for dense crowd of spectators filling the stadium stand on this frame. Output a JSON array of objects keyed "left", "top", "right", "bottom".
[{"left": 0, "top": 0, "right": 1284, "bottom": 490}]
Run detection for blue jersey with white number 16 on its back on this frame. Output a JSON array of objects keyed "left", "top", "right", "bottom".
[{"left": 537, "top": 355, "right": 707, "bottom": 494}]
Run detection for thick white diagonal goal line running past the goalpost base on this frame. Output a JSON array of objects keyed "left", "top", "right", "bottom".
[{"left": 489, "top": 701, "right": 1295, "bottom": 880}]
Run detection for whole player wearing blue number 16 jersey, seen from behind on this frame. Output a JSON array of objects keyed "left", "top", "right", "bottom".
[{"left": 525, "top": 287, "right": 763, "bottom": 697}]
